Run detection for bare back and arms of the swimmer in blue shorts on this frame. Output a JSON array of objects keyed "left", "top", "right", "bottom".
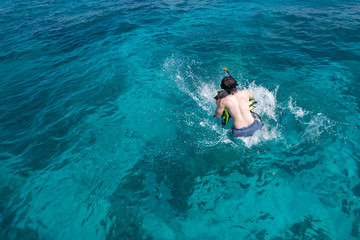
[{"left": 215, "top": 90, "right": 254, "bottom": 129}]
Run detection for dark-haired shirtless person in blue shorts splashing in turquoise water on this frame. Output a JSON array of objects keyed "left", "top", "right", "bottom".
[{"left": 215, "top": 77, "right": 262, "bottom": 137}]
